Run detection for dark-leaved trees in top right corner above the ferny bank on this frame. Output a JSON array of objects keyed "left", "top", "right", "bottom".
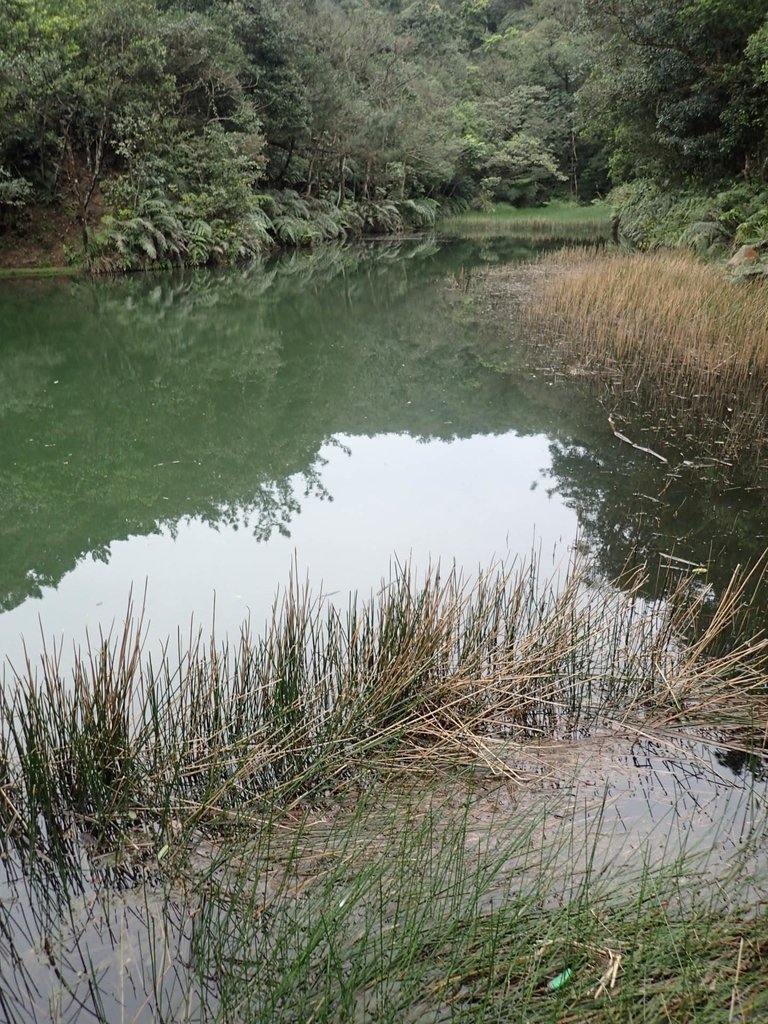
[{"left": 580, "top": 0, "right": 768, "bottom": 188}]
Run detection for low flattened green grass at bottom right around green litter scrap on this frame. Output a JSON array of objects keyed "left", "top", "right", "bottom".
[{"left": 169, "top": 774, "right": 768, "bottom": 1022}]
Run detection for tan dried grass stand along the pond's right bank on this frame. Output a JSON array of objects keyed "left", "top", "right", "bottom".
[{"left": 525, "top": 250, "right": 768, "bottom": 391}]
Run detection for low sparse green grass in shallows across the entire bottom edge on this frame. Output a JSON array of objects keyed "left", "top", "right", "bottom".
[{"left": 0, "top": 774, "right": 768, "bottom": 1024}]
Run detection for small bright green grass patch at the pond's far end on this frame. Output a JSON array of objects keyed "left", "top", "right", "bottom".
[{"left": 438, "top": 202, "right": 610, "bottom": 242}]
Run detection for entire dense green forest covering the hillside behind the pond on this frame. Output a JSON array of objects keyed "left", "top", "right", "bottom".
[{"left": 0, "top": 0, "right": 768, "bottom": 269}]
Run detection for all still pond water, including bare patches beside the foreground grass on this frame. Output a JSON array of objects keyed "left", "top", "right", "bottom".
[{"left": 0, "top": 242, "right": 768, "bottom": 1022}]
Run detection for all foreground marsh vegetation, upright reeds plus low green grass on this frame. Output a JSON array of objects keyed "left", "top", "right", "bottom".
[{"left": 0, "top": 562, "right": 768, "bottom": 1024}]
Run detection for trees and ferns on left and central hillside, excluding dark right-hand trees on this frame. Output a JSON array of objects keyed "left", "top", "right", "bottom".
[{"left": 0, "top": 0, "right": 602, "bottom": 260}]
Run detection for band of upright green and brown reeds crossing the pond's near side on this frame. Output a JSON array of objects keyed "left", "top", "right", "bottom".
[{"left": 0, "top": 565, "right": 768, "bottom": 850}]
